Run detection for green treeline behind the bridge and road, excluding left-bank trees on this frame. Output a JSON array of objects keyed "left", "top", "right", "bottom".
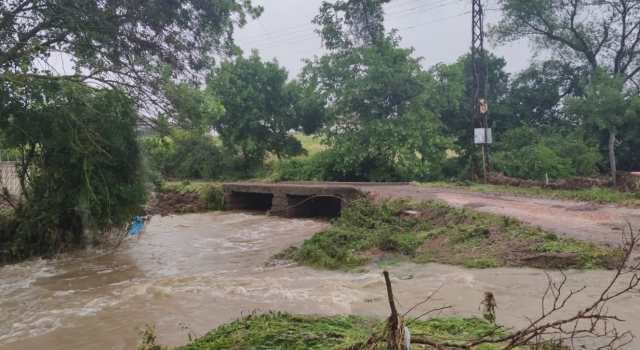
[{"left": 142, "top": 0, "right": 640, "bottom": 185}]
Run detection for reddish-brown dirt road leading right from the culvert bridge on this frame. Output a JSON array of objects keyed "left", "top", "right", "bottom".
[{"left": 359, "top": 184, "right": 640, "bottom": 246}]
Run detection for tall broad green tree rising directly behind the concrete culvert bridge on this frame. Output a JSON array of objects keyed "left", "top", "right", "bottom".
[{"left": 300, "top": 0, "right": 450, "bottom": 181}]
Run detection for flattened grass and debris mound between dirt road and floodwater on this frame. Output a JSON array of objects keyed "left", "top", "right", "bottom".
[{"left": 273, "top": 198, "right": 621, "bottom": 269}]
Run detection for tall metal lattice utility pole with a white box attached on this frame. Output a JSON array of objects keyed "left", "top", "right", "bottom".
[{"left": 470, "top": 0, "right": 489, "bottom": 181}]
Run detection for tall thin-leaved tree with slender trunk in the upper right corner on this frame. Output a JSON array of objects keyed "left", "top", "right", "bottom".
[{"left": 489, "top": 0, "right": 640, "bottom": 182}]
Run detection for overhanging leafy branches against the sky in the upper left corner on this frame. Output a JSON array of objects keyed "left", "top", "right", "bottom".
[{"left": 0, "top": 0, "right": 262, "bottom": 110}]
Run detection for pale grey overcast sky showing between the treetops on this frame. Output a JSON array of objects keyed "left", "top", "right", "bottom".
[{"left": 235, "top": 0, "right": 531, "bottom": 78}]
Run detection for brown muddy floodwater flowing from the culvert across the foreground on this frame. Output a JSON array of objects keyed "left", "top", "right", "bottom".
[{"left": 0, "top": 212, "right": 640, "bottom": 350}]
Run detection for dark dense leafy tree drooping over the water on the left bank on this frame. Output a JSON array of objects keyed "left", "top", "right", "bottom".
[{"left": 0, "top": 81, "right": 146, "bottom": 259}]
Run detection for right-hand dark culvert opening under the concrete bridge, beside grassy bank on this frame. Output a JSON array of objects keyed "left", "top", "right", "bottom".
[{"left": 271, "top": 194, "right": 343, "bottom": 218}]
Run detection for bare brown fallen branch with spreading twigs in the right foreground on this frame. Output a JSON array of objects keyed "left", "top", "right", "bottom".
[{"left": 356, "top": 224, "right": 640, "bottom": 350}]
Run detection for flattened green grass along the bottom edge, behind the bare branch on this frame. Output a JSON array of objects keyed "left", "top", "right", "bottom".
[{"left": 145, "top": 312, "right": 507, "bottom": 350}]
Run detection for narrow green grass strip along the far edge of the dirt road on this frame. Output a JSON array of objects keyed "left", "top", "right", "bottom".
[{"left": 417, "top": 182, "right": 640, "bottom": 205}]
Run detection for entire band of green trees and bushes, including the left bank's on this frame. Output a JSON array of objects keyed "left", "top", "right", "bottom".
[{"left": 0, "top": 0, "right": 640, "bottom": 259}]
